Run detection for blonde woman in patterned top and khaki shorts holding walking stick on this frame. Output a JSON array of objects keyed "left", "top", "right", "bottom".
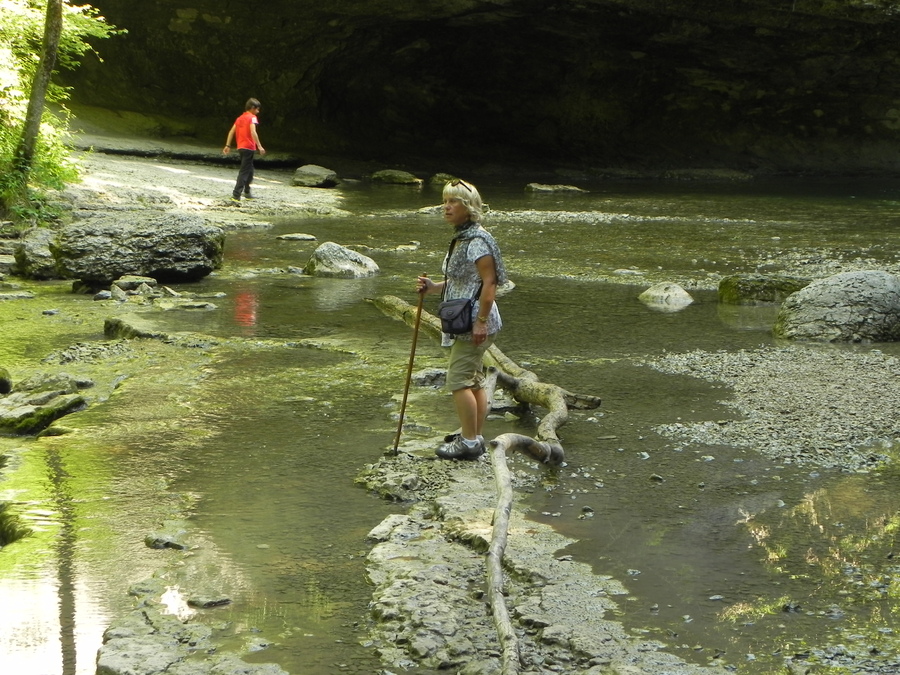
[{"left": 418, "top": 180, "right": 506, "bottom": 459}]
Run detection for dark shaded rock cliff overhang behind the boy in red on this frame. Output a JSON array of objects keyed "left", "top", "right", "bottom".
[{"left": 66, "top": 0, "right": 900, "bottom": 172}]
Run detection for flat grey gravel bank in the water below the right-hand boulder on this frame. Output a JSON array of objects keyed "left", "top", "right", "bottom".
[{"left": 646, "top": 344, "right": 900, "bottom": 471}]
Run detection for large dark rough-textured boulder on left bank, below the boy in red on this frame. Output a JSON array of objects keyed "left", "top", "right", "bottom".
[{"left": 50, "top": 211, "right": 225, "bottom": 285}]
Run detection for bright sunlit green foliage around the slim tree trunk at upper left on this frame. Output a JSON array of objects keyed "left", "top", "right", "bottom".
[{"left": 0, "top": 0, "right": 123, "bottom": 224}]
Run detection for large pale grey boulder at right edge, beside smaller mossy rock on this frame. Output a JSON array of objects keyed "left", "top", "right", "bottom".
[{"left": 774, "top": 271, "right": 900, "bottom": 342}]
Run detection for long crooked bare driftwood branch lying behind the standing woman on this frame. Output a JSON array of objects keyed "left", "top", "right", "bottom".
[{"left": 372, "top": 295, "right": 600, "bottom": 675}]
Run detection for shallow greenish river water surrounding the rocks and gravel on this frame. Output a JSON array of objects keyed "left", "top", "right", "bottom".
[{"left": 0, "top": 172, "right": 900, "bottom": 675}]
